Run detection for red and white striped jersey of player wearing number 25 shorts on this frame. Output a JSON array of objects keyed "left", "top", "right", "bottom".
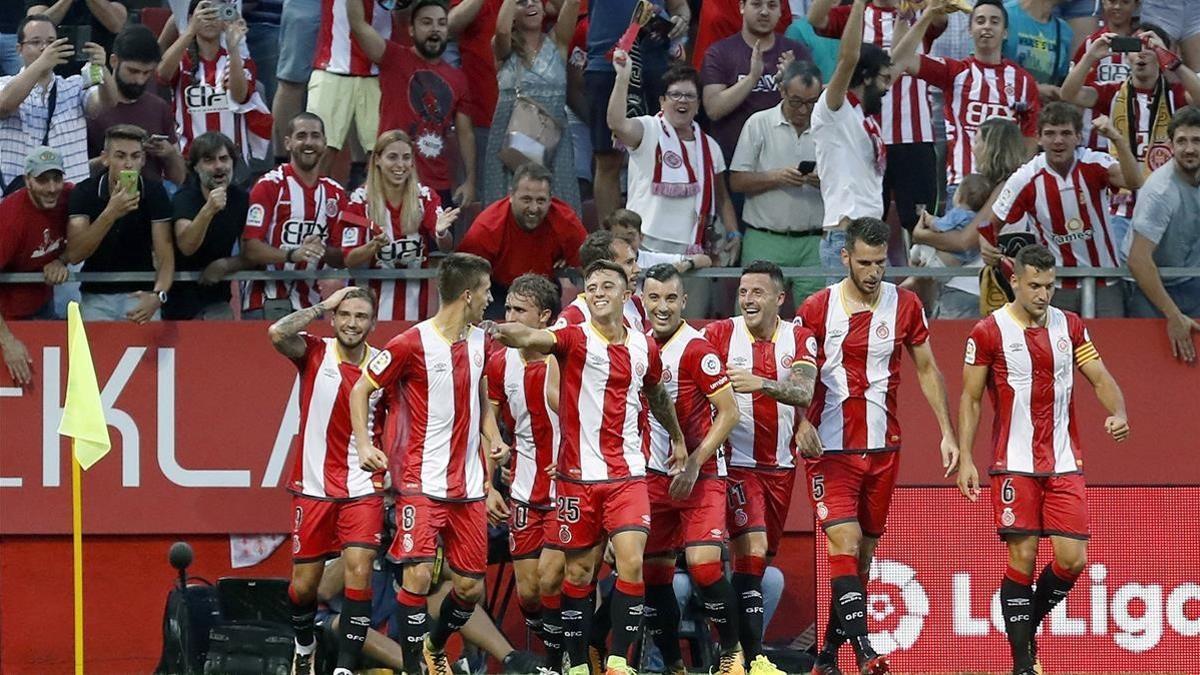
[{"left": 553, "top": 322, "right": 662, "bottom": 483}]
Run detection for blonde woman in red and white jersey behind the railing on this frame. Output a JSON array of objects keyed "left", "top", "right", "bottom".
[{"left": 330, "top": 130, "right": 458, "bottom": 321}]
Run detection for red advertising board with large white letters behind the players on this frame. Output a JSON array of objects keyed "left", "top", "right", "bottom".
[{"left": 0, "top": 319, "right": 1200, "bottom": 534}]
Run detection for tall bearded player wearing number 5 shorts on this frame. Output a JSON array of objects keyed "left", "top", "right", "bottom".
[{"left": 796, "top": 218, "right": 959, "bottom": 675}]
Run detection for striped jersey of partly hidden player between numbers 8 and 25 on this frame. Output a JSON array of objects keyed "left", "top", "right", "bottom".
[{"left": 486, "top": 347, "right": 560, "bottom": 508}]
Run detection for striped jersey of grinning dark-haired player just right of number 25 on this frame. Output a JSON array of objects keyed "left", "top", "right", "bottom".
[{"left": 649, "top": 322, "right": 730, "bottom": 477}]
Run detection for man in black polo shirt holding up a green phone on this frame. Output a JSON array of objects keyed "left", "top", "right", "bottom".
[{"left": 66, "top": 124, "right": 175, "bottom": 323}]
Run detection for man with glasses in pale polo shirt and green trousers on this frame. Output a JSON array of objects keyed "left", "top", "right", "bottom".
[{"left": 730, "top": 61, "right": 824, "bottom": 306}]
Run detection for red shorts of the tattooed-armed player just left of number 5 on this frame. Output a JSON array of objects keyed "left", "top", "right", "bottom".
[{"left": 726, "top": 466, "right": 796, "bottom": 555}]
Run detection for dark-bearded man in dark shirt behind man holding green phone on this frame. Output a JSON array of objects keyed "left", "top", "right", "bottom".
[{"left": 88, "top": 24, "right": 187, "bottom": 186}]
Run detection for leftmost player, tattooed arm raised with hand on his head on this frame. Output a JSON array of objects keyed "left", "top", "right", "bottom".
[{"left": 268, "top": 283, "right": 388, "bottom": 675}]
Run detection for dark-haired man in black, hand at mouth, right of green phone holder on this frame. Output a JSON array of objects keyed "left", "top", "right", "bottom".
[{"left": 166, "top": 133, "right": 250, "bottom": 321}]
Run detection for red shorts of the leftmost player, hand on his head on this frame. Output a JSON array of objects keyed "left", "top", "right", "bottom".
[{"left": 292, "top": 495, "right": 383, "bottom": 562}]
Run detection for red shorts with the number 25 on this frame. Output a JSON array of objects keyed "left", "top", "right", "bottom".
[{"left": 547, "top": 478, "right": 650, "bottom": 551}]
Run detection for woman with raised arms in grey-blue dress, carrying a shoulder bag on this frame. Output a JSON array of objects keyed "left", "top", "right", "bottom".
[{"left": 482, "top": 0, "right": 580, "bottom": 211}]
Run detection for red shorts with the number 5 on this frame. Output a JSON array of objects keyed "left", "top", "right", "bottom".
[{"left": 804, "top": 450, "right": 900, "bottom": 538}]
